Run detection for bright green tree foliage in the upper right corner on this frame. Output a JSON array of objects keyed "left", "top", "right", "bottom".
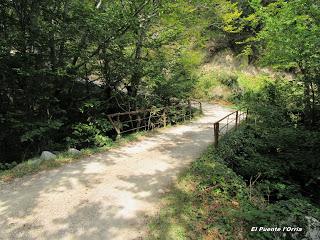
[{"left": 257, "top": 0, "right": 320, "bottom": 74}]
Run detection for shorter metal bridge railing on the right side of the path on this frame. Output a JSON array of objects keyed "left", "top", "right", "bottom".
[{"left": 213, "top": 110, "right": 248, "bottom": 147}]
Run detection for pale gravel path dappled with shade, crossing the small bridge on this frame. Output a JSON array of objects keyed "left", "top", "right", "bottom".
[{"left": 0, "top": 104, "right": 230, "bottom": 240}]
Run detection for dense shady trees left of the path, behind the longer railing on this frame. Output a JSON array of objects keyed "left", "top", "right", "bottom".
[{"left": 0, "top": 0, "right": 206, "bottom": 163}]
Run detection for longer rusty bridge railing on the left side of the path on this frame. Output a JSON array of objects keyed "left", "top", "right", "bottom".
[{"left": 107, "top": 100, "right": 202, "bottom": 137}]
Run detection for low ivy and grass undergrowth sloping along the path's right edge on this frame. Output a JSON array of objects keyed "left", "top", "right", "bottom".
[{"left": 149, "top": 127, "right": 320, "bottom": 240}]
